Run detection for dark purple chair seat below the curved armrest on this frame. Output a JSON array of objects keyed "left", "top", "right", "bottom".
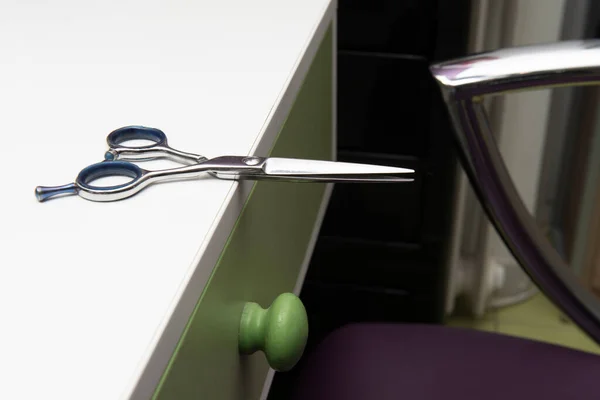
[{"left": 292, "top": 324, "right": 600, "bottom": 400}]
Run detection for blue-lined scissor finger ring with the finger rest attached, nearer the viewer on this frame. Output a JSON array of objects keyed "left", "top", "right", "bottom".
[{"left": 75, "top": 161, "right": 144, "bottom": 191}]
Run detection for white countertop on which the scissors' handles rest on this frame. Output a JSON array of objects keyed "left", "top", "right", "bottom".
[{"left": 0, "top": 0, "right": 333, "bottom": 400}]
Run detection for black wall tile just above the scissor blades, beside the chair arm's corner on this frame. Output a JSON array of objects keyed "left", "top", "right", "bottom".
[{"left": 337, "top": 52, "right": 433, "bottom": 156}]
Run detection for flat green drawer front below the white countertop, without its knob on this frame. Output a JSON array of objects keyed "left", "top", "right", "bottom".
[{"left": 154, "top": 27, "right": 333, "bottom": 400}]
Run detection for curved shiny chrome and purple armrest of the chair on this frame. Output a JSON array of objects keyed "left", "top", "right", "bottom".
[{"left": 430, "top": 40, "right": 600, "bottom": 344}]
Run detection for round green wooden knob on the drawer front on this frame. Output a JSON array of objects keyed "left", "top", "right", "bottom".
[{"left": 238, "top": 293, "right": 308, "bottom": 371}]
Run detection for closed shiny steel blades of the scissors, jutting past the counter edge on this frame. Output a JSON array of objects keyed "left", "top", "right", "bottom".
[{"left": 262, "top": 157, "right": 415, "bottom": 182}]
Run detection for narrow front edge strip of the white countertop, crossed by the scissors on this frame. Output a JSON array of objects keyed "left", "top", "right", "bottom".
[{"left": 123, "top": 0, "right": 337, "bottom": 400}]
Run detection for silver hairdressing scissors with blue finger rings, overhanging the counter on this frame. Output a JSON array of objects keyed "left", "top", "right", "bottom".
[{"left": 35, "top": 126, "right": 414, "bottom": 202}]
